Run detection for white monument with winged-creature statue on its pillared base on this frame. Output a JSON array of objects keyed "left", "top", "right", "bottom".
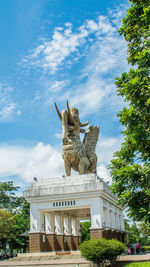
[{"left": 24, "top": 103, "right": 125, "bottom": 252}]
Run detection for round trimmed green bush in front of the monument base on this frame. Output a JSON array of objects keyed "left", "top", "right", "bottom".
[{"left": 80, "top": 238, "right": 125, "bottom": 266}]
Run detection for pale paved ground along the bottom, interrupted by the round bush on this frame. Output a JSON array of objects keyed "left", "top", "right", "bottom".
[{"left": 0, "top": 253, "right": 150, "bottom": 267}]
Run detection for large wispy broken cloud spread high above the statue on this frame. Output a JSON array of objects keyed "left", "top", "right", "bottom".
[{"left": 21, "top": 6, "right": 127, "bottom": 115}]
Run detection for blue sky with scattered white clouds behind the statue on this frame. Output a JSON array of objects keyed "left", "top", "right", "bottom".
[{"left": 0, "top": 0, "right": 128, "bottom": 193}]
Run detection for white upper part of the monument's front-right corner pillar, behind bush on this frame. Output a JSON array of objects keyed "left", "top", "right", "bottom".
[{"left": 91, "top": 198, "right": 104, "bottom": 228}]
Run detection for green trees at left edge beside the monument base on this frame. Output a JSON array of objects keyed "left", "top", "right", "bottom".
[{"left": 0, "top": 182, "right": 29, "bottom": 252}]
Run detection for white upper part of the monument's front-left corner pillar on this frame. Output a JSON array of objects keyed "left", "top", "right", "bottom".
[{"left": 30, "top": 203, "right": 42, "bottom": 232}]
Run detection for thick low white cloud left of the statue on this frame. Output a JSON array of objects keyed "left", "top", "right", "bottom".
[{"left": 0, "top": 143, "right": 64, "bottom": 182}]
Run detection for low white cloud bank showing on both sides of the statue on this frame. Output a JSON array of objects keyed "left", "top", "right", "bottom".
[{"left": 0, "top": 136, "right": 121, "bottom": 183}]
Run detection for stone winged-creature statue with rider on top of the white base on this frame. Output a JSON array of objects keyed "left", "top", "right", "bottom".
[{"left": 55, "top": 101, "right": 99, "bottom": 176}]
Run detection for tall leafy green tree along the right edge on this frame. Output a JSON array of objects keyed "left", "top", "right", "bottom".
[{"left": 109, "top": 0, "right": 150, "bottom": 222}]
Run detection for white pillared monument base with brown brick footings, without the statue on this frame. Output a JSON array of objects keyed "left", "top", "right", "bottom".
[{"left": 24, "top": 174, "right": 125, "bottom": 252}]
